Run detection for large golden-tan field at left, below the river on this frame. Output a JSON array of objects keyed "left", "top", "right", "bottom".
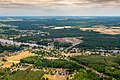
[{"left": 2, "top": 51, "right": 37, "bottom": 67}]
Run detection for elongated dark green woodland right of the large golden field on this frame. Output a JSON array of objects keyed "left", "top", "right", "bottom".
[{"left": 21, "top": 57, "right": 82, "bottom": 71}]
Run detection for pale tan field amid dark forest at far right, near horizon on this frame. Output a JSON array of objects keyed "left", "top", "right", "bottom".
[{"left": 80, "top": 27, "right": 120, "bottom": 35}]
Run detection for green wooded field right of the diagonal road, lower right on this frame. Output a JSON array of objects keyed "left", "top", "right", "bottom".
[{"left": 71, "top": 55, "right": 120, "bottom": 80}]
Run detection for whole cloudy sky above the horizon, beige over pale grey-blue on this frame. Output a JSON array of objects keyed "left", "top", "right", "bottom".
[{"left": 0, "top": 0, "right": 120, "bottom": 16}]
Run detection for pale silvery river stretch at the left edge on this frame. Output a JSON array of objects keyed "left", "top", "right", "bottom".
[{"left": 0, "top": 39, "right": 40, "bottom": 47}]
